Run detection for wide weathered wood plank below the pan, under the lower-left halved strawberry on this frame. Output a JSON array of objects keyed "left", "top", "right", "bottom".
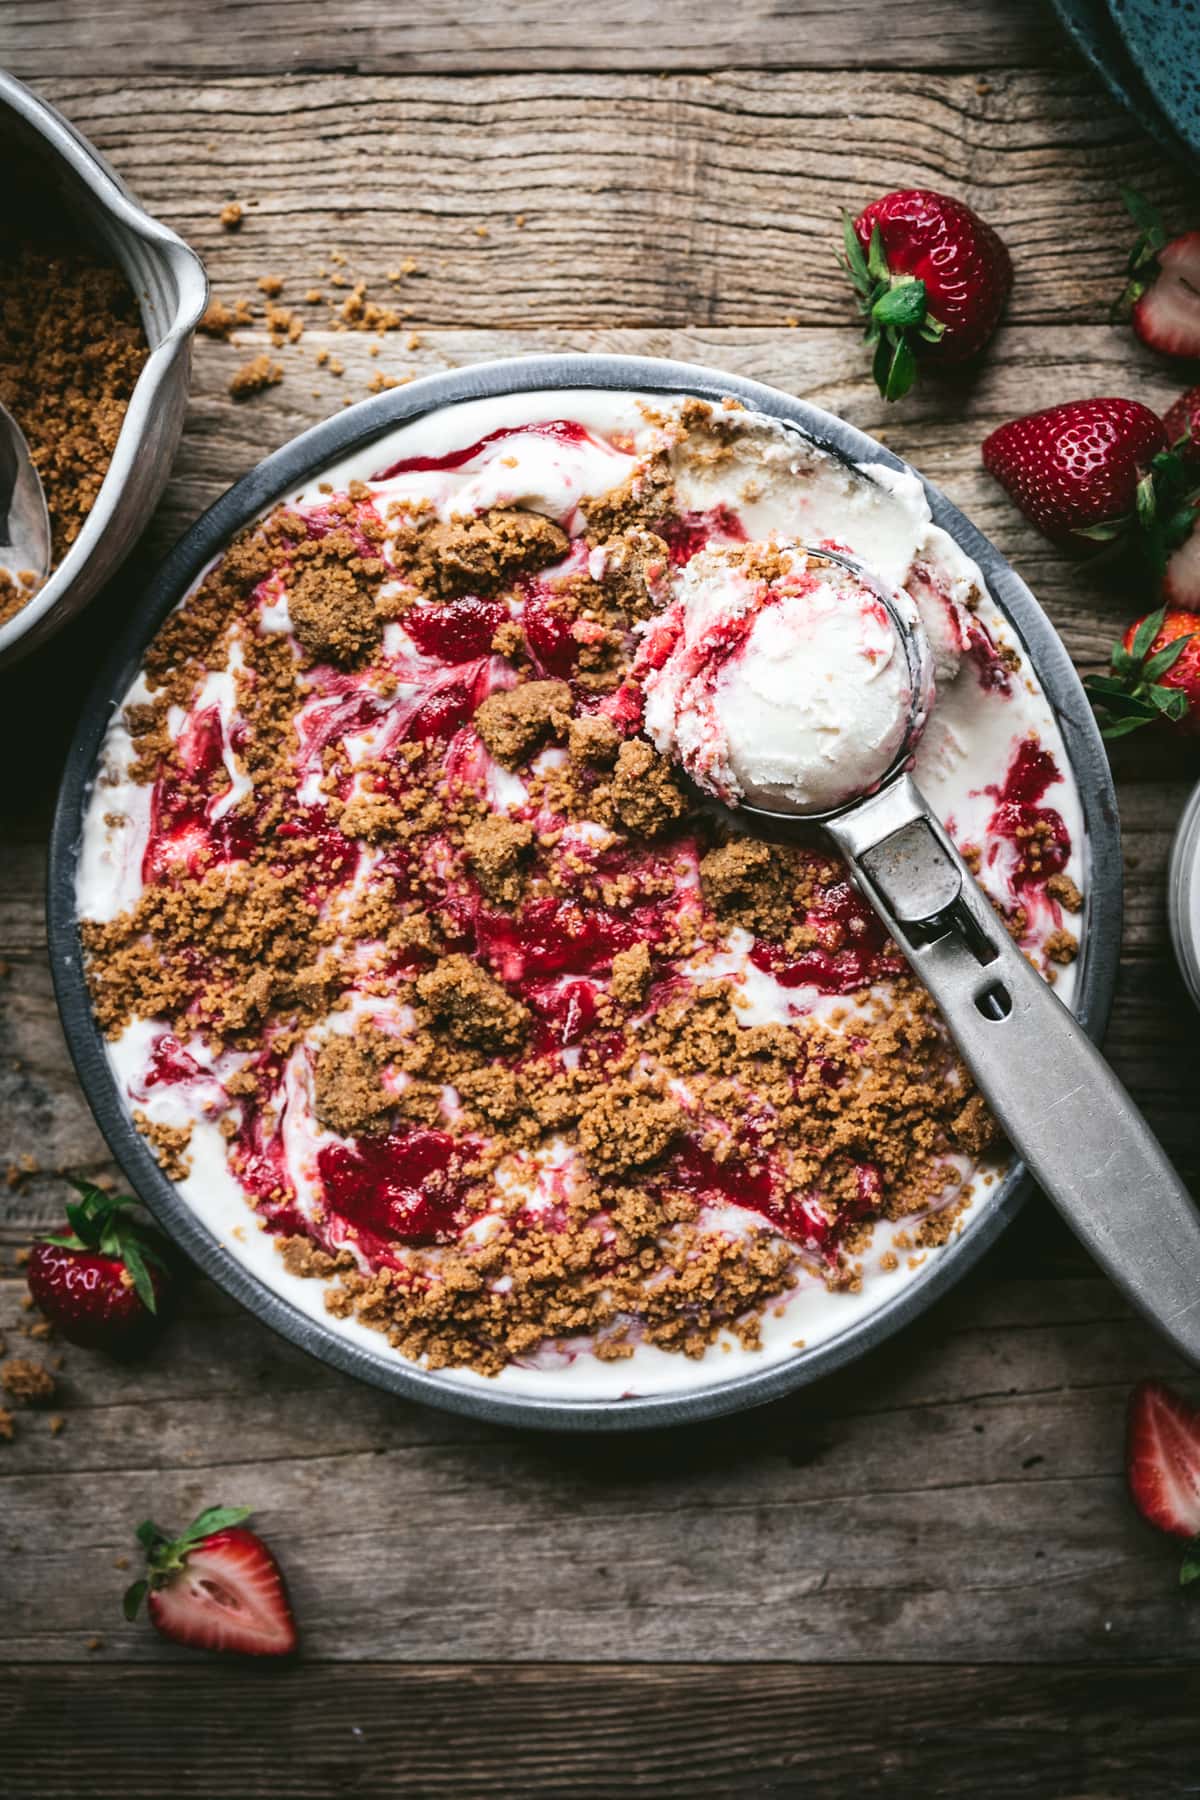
[{"left": 0, "top": 1276, "right": 1200, "bottom": 1663}]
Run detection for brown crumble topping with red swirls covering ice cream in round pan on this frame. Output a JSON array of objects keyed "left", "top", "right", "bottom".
[{"left": 83, "top": 397, "right": 1065, "bottom": 1373}]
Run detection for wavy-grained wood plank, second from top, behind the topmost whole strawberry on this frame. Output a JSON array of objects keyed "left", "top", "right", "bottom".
[{"left": 18, "top": 72, "right": 1186, "bottom": 329}]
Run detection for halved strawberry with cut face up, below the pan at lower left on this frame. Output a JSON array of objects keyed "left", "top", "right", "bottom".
[{"left": 124, "top": 1507, "right": 297, "bottom": 1656}]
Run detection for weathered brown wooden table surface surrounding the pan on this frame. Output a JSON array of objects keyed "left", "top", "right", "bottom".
[{"left": 0, "top": 0, "right": 1200, "bottom": 1800}]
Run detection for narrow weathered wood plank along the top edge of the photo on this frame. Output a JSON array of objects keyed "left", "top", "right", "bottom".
[{"left": 5, "top": 0, "right": 1063, "bottom": 81}]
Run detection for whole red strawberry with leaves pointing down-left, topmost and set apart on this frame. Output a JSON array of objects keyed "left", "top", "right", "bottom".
[{"left": 842, "top": 187, "right": 1013, "bottom": 400}]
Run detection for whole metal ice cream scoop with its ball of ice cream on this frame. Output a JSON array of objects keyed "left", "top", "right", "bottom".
[{"left": 642, "top": 493, "right": 1200, "bottom": 1363}]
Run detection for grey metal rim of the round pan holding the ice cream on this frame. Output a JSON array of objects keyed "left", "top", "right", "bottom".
[{"left": 49, "top": 355, "right": 1121, "bottom": 1431}]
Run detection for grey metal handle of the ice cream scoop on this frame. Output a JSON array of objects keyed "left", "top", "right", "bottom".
[{"left": 826, "top": 776, "right": 1200, "bottom": 1364}]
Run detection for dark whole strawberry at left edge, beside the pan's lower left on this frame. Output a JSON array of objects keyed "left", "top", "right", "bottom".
[{"left": 25, "top": 1181, "right": 175, "bottom": 1355}]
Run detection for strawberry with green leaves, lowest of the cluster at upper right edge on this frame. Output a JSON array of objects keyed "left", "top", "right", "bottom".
[{"left": 1083, "top": 607, "right": 1200, "bottom": 738}]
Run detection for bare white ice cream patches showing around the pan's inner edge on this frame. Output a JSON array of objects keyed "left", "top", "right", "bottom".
[{"left": 77, "top": 389, "right": 1085, "bottom": 1400}]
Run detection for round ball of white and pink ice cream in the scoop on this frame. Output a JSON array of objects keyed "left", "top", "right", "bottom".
[{"left": 637, "top": 542, "right": 932, "bottom": 814}]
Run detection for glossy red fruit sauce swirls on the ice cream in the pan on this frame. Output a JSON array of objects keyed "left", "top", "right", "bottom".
[{"left": 126, "top": 419, "right": 1070, "bottom": 1267}]
